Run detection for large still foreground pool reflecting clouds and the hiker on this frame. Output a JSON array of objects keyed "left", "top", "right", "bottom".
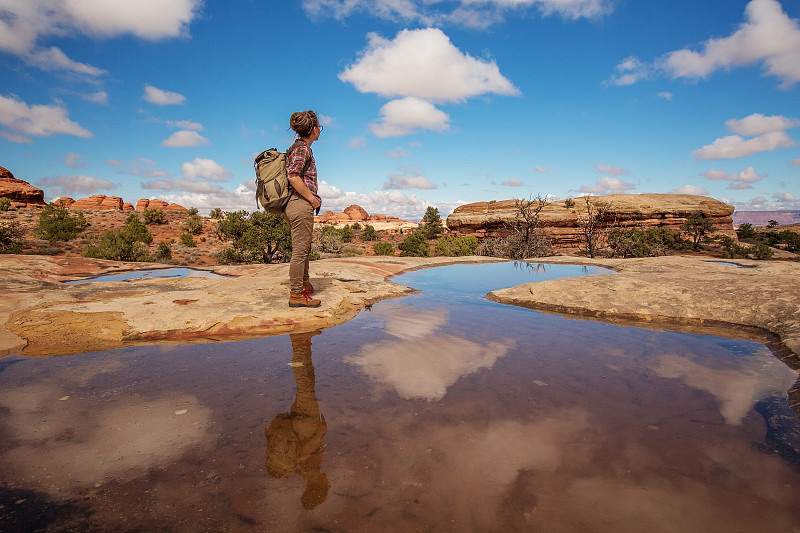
[{"left": 0, "top": 263, "right": 800, "bottom": 532}]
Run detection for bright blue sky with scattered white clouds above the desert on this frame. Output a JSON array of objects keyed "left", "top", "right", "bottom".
[{"left": 0, "top": 0, "right": 800, "bottom": 220}]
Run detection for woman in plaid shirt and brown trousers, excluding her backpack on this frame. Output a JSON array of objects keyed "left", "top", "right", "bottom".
[{"left": 283, "top": 111, "right": 322, "bottom": 307}]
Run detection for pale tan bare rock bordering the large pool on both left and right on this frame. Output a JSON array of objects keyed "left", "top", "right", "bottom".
[{"left": 0, "top": 255, "right": 800, "bottom": 362}]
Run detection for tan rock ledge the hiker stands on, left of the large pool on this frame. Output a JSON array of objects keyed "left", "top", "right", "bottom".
[{"left": 0, "top": 255, "right": 494, "bottom": 356}]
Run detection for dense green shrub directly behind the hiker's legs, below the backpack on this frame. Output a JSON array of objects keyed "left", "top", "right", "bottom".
[{"left": 216, "top": 211, "right": 292, "bottom": 265}]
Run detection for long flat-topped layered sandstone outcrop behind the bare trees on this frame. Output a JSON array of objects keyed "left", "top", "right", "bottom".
[{"left": 446, "top": 194, "right": 736, "bottom": 249}]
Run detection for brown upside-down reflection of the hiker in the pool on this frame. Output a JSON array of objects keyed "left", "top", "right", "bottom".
[{"left": 264, "top": 331, "right": 331, "bottom": 509}]
